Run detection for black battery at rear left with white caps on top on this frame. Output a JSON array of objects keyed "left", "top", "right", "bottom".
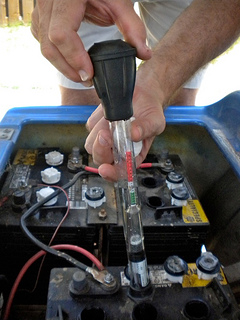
[{"left": 0, "top": 148, "right": 98, "bottom": 303}]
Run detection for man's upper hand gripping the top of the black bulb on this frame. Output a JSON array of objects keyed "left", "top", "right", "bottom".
[{"left": 31, "top": 0, "right": 151, "bottom": 85}]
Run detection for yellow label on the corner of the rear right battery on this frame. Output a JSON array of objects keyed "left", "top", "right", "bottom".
[{"left": 182, "top": 200, "right": 208, "bottom": 223}]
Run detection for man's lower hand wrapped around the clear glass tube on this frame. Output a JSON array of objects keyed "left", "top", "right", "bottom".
[{"left": 85, "top": 62, "right": 165, "bottom": 181}]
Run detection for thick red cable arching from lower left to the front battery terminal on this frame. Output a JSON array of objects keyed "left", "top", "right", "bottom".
[{"left": 3, "top": 244, "right": 104, "bottom": 320}]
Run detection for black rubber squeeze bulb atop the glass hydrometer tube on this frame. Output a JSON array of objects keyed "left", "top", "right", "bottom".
[{"left": 88, "top": 40, "right": 136, "bottom": 121}]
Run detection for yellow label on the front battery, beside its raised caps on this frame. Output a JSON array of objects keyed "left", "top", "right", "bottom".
[{"left": 182, "top": 263, "right": 227, "bottom": 288}]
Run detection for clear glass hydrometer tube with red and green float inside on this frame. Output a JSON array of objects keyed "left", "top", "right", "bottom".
[{"left": 110, "top": 119, "right": 150, "bottom": 295}]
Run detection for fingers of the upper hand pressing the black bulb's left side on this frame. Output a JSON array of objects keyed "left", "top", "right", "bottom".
[{"left": 35, "top": 0, "right": 93, "bottom": 82}]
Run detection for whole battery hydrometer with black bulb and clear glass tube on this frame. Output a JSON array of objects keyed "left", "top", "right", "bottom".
[{"left": 89, "top": 40, "right": 152, "bottom": 299}]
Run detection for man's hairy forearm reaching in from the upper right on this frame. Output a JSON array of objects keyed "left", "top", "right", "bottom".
[{"left": 139, "top": 0, "right": 240, "bottom": 106}]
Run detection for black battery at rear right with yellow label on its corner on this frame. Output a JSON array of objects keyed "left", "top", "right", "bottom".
[{"left": 108, "top": 155, "right": 210, "bottom": 266}]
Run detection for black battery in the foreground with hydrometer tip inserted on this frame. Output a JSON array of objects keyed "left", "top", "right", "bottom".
[{"left": 46, "top": 263, "right": 240, "bottom": 320}]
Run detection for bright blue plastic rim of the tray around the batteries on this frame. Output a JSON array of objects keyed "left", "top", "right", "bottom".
[{"left": 0, "top": 91, "right": 240, "bottom": 178}]
